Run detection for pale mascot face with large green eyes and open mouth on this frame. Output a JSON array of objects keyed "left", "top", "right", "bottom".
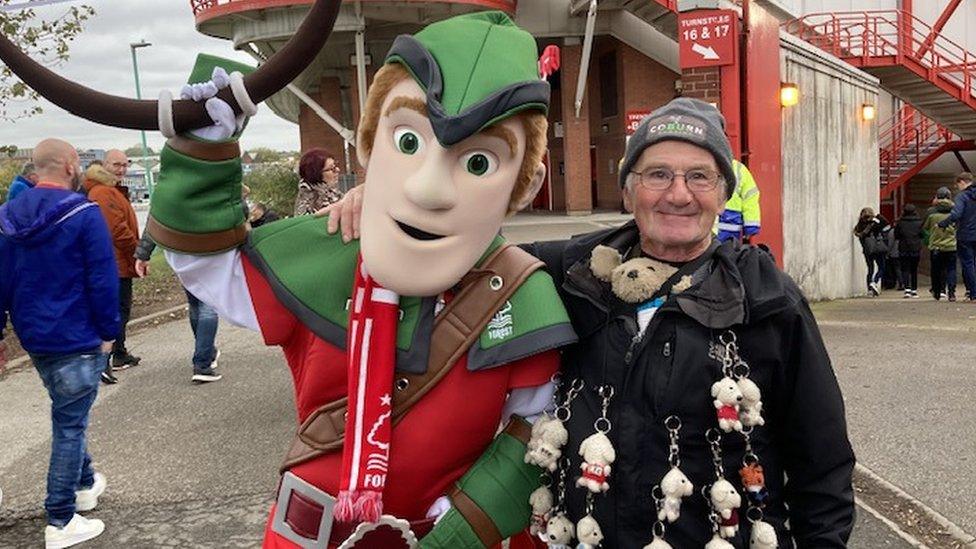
[{"left": 362, "top": 79, "right": 525, "bottom": 296}]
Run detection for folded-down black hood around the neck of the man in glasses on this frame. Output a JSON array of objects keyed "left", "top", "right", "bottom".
[{"left": 564, "top": 221, "right": 802, "bottom": 329}]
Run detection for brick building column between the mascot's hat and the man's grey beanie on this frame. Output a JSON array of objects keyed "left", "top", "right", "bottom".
[{"left": 559, "top": 44, "right": 593, "bottom": 215}]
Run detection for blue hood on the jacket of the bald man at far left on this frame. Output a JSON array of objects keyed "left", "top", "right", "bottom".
[{"left": 0, "top": 191, "right": 97, "bottom": 242}]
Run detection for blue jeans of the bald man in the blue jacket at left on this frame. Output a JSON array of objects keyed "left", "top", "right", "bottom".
[{"left": 31, "top": 349, "right": 109, "bottom": 527}]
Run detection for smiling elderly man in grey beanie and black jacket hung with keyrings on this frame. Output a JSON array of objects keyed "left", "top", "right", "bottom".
[{"left": 330, "top": 98, "right": 854, "bottom": 549}]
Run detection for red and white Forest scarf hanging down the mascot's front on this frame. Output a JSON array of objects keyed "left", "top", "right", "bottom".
[{"left": 335, "top": 258, "right": 400, "bottom": 522}]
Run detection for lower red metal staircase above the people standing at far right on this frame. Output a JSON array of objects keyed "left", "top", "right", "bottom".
[{"left": 878, "top": 105, "right": 976, "bottom": 199}]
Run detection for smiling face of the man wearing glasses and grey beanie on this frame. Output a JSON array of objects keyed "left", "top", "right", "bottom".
[{"left": 624, "top": 141, "right": 725, "bottom": 255}]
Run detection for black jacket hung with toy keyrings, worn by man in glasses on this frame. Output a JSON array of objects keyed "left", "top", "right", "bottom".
[{"left": 526, "top": 222, "right": 854, "bottom": 549}]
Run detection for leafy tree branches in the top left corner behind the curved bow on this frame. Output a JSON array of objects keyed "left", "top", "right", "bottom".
[{"left": 0, "top": 0, "right": 95, "bottom": 121}]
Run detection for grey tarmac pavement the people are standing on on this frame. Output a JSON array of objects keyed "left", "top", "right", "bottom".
[{"left": 0, "top": 216, "right": 952, "bottom": 549}]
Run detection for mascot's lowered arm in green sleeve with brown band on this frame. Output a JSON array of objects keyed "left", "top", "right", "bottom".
[{"left": 420, "top": 416, "right": 542, "bottom": 549}]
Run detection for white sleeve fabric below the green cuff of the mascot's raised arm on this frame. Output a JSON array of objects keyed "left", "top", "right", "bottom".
[{"left": 166, "top": 250, "right": 260, "bottom": 332}]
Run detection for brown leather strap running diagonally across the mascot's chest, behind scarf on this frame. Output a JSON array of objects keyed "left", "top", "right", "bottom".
[{"left": 281, "top": 245, "right": 543, "bottom": 472}]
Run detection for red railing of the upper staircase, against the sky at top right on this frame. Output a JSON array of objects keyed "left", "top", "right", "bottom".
[{"left": 783, "top": 10, "right": 976, "bottom": 103}]
